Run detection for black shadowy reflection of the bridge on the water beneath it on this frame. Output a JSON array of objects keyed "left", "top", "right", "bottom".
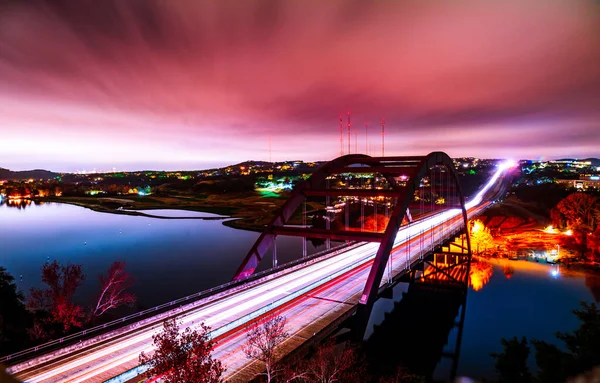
[{"left": 365, "top": 271, "right": 467, "bottom": 380}]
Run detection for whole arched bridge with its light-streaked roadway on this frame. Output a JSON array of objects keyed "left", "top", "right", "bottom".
[{"left": 0, "top": 152, "right": 508, "bottom": 383}]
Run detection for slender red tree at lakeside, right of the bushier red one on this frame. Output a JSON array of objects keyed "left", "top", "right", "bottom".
[{"left": 93, "top": 261, "right": 135, "bottom": 317}]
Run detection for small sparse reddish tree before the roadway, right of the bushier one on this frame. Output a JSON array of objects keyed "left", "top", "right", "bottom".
[{"left": 244, "top": 316, "right": 289, "bottom": 382}]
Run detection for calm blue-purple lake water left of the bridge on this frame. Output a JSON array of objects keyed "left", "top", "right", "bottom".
[{"left": 0, "top": 203, "right": 324, "bottom": 308}]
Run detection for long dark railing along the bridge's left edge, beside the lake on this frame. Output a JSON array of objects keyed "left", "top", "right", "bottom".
[{"left": 0, "top": 243, "right": 354, "bottom": 364}]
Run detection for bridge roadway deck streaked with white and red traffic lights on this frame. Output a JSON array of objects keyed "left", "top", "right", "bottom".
[{"left": 7, "top": 168, "right": 505, "bottom": 383}]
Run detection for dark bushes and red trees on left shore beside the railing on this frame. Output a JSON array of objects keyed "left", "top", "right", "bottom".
[{"left": 0, "top": 261, "right": 135, "bottom": 355}]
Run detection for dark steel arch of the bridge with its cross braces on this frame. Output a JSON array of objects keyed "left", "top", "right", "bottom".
[{"left": 233, "top": 152, "right": 471, "bottom": 305}]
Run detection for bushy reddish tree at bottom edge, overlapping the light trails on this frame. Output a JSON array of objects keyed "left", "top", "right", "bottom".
[{"left": 139, "top": 319, "right": 225, "bottom": 383}]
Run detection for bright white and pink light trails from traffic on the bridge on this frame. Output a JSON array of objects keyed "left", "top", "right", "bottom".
[{"left": 8, "top": 166, "right": 507, "bottom": 383}]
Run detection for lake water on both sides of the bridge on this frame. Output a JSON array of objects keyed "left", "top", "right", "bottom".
[{"left": 0, "top": 203, "right": 600, "bottom": 377}]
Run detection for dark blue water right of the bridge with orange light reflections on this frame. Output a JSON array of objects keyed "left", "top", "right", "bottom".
[{"left": 366, "top": 260, "right": 600, "bottom": 381}]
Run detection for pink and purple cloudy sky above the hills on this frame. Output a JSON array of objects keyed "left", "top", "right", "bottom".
[{"left": 0, "top": 0, "right": 600, "bottom": 171}]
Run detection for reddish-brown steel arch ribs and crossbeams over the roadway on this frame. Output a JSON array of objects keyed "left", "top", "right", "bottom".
[{"left": 233, "top": 152, "right": 471, "bottom": 305}]
